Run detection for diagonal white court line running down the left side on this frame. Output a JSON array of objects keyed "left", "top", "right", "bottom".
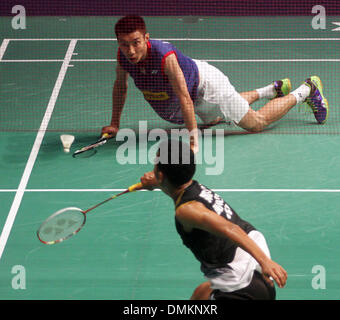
[{"left": 0, "top": 40, "right": 77, "bottom": 259}]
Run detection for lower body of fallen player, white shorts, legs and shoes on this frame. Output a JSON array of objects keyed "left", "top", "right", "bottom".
[{"left": 195, "top": 60, "right": 328, "bottom": 132}]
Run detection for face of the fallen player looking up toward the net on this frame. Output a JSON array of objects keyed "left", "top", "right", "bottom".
[{"left": 117, "top": 31, "right": 149, "bottom": 64}]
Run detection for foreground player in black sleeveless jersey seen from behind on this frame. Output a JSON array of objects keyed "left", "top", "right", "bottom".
[{"left": 141, "top": 140, "right": 287, "bottom": 300}]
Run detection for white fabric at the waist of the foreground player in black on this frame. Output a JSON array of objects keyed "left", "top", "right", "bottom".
[{"left": 208, "top": 230, "right": 270, "bottom": 292}]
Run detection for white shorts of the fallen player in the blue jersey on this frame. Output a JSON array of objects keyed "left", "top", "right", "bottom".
[{"left": 194, "top": 60, "right": 249, "bottom": 124}]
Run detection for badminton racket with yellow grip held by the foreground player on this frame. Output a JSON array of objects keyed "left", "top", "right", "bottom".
[{"left": 37, "top": 182, "right": 142, "bottom": 244}]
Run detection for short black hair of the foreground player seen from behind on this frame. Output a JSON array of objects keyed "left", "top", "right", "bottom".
[{"left": 156, "top": 140, "right": 196, "bottom": 187}]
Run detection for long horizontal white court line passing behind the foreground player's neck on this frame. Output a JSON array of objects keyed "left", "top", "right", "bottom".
[{"left": 0, "top": 188, "right": 340, "bottom": 193}]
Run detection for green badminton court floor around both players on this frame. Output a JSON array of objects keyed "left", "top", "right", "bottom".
[{"left": 0, "top": 17, "right": 340, "bottom": 300}]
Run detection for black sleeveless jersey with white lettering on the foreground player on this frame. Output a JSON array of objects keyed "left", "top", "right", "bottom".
[{"left": 175, "top": 180, "right": 256, "bottom": 277}]
